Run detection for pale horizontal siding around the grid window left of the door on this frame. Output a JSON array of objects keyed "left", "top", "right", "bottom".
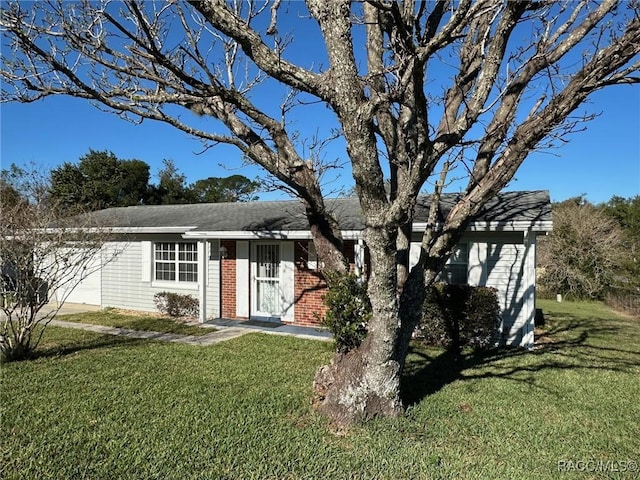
[{"left": 102, "top": 238, "right": 219, "bottom": 318}]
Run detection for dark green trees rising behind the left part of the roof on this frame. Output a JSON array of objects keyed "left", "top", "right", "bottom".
[{"left": 41, "top": 150, "right": 260, "bottom": 213}]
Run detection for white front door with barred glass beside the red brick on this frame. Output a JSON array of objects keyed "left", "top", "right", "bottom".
[{"left": 252, "top": 242, "right": 282, "bottom": 318}]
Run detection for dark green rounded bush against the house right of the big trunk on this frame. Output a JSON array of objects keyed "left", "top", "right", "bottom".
[{"left": 417, "top": 283, "right": 500, "bottom": 350}]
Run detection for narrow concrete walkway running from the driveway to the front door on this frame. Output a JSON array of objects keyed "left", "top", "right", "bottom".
[{"left": 45, "top": 304, "right": 333, "bottom": 346}]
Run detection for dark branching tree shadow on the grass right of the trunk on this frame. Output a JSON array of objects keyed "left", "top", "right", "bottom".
[{"left": 401, "top": 315, "right": 640, "bottom": 406}]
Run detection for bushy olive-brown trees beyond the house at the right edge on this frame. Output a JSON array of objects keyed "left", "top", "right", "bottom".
[{"left": 538, "top": 195, "right": 640, "bottom": 309}]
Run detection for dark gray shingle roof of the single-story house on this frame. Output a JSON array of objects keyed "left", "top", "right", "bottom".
[{"left": 81, "top": 191, "right": 551, "bottom": 232}]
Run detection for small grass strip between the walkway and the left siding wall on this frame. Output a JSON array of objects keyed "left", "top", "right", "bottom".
[{"left": 56, "top": 308, "right": 215, "bottom": 336}]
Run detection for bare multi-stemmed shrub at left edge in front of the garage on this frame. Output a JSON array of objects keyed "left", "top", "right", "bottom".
[{"left": 0, "top": 169, "right": 117, "bottom": 361}]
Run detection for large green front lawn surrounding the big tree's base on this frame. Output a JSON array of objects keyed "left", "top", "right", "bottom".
[{"left": 0, "top": 302, "right": 640, "bottom": 479}]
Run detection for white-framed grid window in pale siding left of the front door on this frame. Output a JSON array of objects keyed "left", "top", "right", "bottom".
[{"left": 153, "top": 242, "right": 198, "bottom": 283}]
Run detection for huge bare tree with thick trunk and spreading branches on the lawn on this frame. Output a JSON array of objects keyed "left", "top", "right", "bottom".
[{"left": 0, "top": 0, "right": 640, "bottom": 423}]
